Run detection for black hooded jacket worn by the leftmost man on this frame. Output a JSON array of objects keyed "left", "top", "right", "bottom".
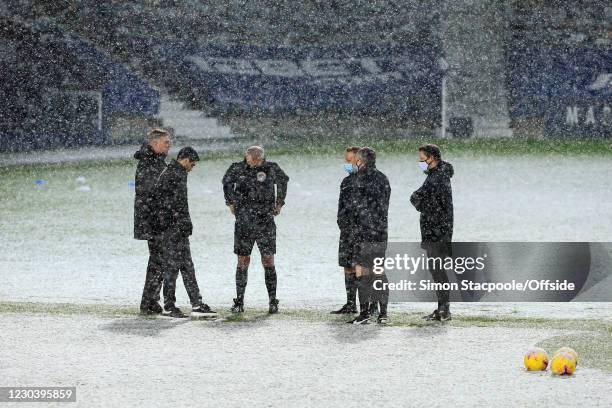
[{"left": 134, "top": 143, "right": 166, "bottom": 240}]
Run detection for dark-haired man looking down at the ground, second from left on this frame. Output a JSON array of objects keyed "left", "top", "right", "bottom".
[{"left": 154, "top": 147, "right": 217, "bottom": 317}]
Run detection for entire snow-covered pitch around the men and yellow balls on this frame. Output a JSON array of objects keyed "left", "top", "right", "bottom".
[{"left": 0, "top": 149, "right": 612, "bottom": 407}]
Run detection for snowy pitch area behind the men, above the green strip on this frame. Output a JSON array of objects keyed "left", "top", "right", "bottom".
[{"left": 0, "top": 152, "right": 612, "bottom": 313}]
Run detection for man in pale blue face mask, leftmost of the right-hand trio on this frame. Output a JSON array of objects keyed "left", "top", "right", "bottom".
[{"left": 331, "top": 147, "right": 359, "bottom": 314}]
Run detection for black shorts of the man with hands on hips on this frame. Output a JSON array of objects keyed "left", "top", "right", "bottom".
[{"left": 234, "top": 219, "right": 276, "bottom": 256}]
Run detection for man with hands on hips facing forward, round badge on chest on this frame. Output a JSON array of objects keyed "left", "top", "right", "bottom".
[{"left": 222, "top": 146, "right": 289, "bottom": 314}]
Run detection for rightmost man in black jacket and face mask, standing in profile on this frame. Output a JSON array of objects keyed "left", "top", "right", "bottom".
[{"left": 410, "top": 144, "right": 454, "bottom": 321}]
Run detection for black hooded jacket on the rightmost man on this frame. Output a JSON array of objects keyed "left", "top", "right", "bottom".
[{"left": 410, "top": 160, "right": 454, "bottom": 242}]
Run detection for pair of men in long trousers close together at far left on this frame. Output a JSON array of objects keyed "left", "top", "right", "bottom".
[{"left": 134, "top": 129, "right": 216, "bottom": 317}]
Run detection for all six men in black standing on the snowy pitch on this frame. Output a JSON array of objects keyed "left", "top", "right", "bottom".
[{"left": 134, "top": 129, "right": 453, "bottom": 324}]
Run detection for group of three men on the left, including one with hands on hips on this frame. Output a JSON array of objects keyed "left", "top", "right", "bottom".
[{"left": 134, "top": 129, "right": 289, "bottom": 318}]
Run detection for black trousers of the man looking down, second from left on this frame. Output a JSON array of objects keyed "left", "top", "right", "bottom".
[{"left": 162, "top": 232, "right": 202, "bottom": 309}]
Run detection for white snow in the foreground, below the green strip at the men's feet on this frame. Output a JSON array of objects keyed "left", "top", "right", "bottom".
[{"left": 0, "top": 314, "right": 612, "bottom": 407}]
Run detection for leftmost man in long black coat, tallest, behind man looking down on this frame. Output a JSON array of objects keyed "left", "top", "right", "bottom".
[{"left": 134, "top": 129, "right": 170, "bottom": 314}]
